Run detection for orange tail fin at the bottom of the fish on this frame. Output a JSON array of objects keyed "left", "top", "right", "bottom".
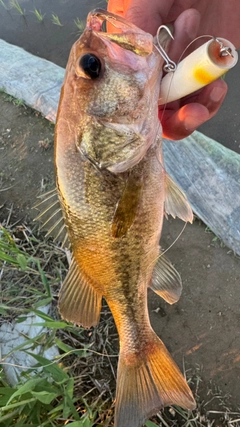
[{"left": 114, "top": 331, "right": 195, "bottom": 427}]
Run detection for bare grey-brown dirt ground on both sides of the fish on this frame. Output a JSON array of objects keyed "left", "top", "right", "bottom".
[{"left": 0, "top": 94, "right": 240, "bottom": 410}]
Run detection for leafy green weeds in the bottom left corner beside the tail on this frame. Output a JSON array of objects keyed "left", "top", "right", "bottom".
[{"left": 0, "top": 352, "right": 88, "bottom": 427}]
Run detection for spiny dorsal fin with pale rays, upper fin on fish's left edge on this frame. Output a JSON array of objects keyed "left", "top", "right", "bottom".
[{"left": 33, "top": 188, "right": 69, "bottom": 247}]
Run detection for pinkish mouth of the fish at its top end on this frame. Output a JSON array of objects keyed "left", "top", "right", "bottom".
[{"left": 86, "top": 9, "right": 153, "bottom": 56}]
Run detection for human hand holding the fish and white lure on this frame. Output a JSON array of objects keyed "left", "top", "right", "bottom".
[{"left": 108, "top": 0, "right": 240, "bottom": 139}]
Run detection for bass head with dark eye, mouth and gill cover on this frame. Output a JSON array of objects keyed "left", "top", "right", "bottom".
[{"left": 57, "top": 9, "right": 170, "bottom": 173}]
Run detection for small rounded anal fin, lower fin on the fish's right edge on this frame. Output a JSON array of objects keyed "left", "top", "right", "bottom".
[{"left": 150, "top": 255, "right": 182, "bottom": 304}]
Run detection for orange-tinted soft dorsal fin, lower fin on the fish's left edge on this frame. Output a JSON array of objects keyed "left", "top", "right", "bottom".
[{"left": 58, "top": 259, "right": 102, "bottom": 328}]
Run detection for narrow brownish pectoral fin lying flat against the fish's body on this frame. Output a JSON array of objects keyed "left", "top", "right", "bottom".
[{"left": 112, "top": 174, "right": 142, "bottom": 238}]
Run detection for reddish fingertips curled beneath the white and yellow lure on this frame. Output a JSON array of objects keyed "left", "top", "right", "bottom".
[{"left": 159, "top": 80, "right": 227, "bottom": 140}]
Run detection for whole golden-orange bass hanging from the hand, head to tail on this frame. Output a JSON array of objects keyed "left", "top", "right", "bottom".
[{"left": 36, "top": 9, "right": 195, "bottom": 427}]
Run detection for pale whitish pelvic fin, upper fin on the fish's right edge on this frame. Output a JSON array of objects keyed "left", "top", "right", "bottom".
[{"left": 165, "top": 173, "right": 193, "bottom": 223}]
